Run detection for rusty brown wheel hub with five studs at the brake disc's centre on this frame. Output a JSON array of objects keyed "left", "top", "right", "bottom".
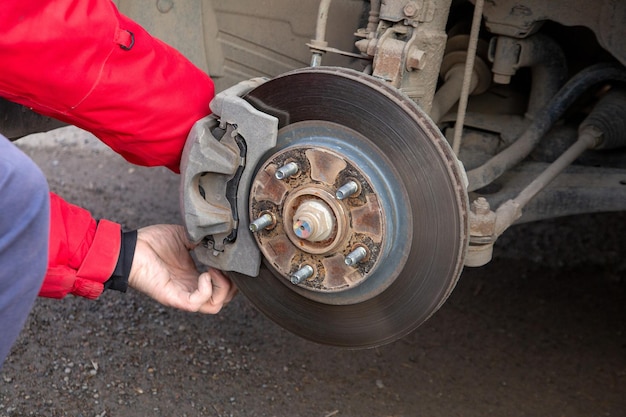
[{"left": 250, "top": 141, "right": 387, "bottom": 294}]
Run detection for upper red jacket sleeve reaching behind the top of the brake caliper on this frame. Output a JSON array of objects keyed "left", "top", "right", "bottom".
[{"left": 0, "top": 0, "right": 214, "bottom": 172}]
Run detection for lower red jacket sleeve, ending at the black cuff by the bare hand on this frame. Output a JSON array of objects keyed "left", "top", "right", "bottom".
[{"left": 39, "top": 193, "right": 121, "bottom": 299}]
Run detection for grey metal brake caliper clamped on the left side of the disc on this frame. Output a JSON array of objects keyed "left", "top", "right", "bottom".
[{"left": 180, "top": 78, "right": 278, "bottom": 276}]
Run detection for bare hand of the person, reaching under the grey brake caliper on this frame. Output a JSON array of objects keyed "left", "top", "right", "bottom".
[{"left": 128, "top": 225, "right": 237, "bottom": 314}]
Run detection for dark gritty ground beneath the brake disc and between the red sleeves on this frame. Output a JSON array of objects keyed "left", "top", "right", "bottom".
[{"left": 0, "top": 129, "right": 626, "bottom": 417}]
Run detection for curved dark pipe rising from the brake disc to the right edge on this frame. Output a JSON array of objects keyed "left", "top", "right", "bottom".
[{"left": 467, "top": 64, "right": 626, "bottom": 191}]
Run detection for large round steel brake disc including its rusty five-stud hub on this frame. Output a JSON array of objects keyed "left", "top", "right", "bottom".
[{"left": 230, "top": 67, "right": 468, "bottom": 348}]
